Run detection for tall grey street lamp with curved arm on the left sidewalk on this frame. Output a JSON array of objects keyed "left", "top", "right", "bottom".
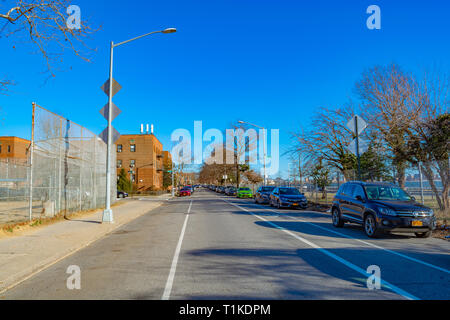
[{"left": 102, "top": 28, "right": 177, "bottom": 223}]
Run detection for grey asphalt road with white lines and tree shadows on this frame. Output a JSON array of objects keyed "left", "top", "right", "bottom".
[{"left": 0, "top": 191, "right": 450, "bottom": 300}]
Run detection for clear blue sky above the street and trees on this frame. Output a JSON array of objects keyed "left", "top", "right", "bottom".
[{"left": 0, "top": 0, "right": 450, "bottom": 178}]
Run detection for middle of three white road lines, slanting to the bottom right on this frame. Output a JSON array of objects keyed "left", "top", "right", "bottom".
[{"left": 223, "top": 200, "right": 420, "bottom": 300}]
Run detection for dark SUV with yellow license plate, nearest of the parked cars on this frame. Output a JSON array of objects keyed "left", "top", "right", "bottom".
[{"left": 331, "top": 181, "right": 436, "bottom": 238}]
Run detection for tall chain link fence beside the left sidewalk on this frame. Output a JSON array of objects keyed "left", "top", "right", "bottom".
[{"left": 0, "top": 105, "right": 117, "bottom": 223}]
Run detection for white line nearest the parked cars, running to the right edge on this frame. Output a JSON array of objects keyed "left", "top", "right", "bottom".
[{"left": 232, "top": 198, "right": 450, "bottom": 274}]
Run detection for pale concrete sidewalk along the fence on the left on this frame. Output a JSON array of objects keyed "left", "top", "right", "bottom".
[{"left": 0, "top": 196, "right": 170, "bottom": 293}]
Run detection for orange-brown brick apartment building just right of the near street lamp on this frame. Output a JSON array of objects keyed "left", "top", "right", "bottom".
[{"left": 116, "top": 134, "right": 170, "bottom": 191}]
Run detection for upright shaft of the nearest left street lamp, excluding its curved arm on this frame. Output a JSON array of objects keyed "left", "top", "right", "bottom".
[{"left": 102, "top": 41, "right": 114, "bottom": 223}]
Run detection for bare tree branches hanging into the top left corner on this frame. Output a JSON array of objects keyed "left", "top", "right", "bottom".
[{"left": 0, "top": 0, "right": 98, "bottom": 91}]
